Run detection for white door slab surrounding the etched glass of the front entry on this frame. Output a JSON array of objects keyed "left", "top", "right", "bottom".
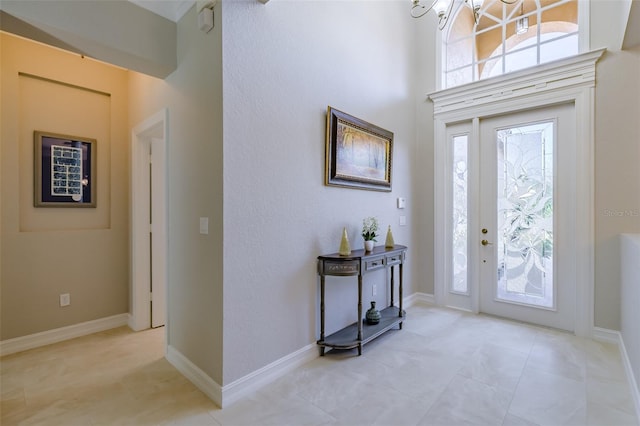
[{"left": 478, "top": 103, "right": 579, "bottom": 332}]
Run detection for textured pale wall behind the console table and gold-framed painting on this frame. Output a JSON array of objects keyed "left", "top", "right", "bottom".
[{"left": 222, "top": 1, "right": 420, "bottom": 385}]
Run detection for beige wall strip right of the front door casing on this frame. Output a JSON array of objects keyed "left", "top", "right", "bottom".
[{"left": 594, "top": 47, "right": 640, "bottom": 330}]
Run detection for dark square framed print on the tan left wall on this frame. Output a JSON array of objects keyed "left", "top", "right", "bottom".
[{"left": 33, "top": 131, "right": 97, "bottom": 207}]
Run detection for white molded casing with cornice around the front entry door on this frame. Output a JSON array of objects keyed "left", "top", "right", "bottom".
[{"left": 429, "top": 49, "right": 604, "bottom": 336}]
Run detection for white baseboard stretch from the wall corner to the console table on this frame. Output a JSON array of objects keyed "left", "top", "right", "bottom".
[{"left": 222, "top": 343, "right": 320, "bottom": 407}]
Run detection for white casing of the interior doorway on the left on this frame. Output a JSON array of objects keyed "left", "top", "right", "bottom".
[{"left": 129, "top": 109, "right": 169, "bottom": 331}]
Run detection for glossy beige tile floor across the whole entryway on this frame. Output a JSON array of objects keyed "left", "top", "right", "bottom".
[{"left": 0, "top": 306, "right": 639, "bottom": 426}]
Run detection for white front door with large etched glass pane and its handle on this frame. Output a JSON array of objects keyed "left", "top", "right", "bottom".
[{"left": 480, "top": 104, "right": 576, "bottom": 331}]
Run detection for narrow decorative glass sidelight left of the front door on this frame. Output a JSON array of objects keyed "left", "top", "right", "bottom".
[{"left": 451, "top": 135, "right": 469, "bottom": 293}]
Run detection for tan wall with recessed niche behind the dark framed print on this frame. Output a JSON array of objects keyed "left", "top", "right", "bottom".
[{"left": 0, "top": 33, "right": 129, "bottom": 340}]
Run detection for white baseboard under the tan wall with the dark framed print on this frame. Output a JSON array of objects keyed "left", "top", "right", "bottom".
[{"left": 0, "top": 314, "right": 129, "bottom": 356}]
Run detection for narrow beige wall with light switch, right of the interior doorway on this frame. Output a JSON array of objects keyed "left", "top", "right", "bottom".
[{"left": 129, "top": 3, "right": 224, "bottom": 385}]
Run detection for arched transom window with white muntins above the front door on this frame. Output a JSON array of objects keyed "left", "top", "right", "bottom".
[{"left": 442, "top": 0, "right": 579, "bottom": 88}]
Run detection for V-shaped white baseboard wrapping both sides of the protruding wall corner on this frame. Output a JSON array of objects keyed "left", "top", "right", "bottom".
[{"left": 167, "top": 344, "right": 320, "bottom": 408}]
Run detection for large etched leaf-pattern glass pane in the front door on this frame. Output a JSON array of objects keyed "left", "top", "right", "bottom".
[{"left": 497, "top": 122, "right": 554, "bottom": 308}]
